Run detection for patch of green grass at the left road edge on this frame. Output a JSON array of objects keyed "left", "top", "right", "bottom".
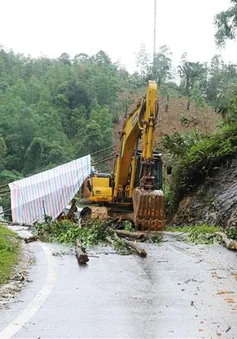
[{"left": 0, "top": 225, "right": 20, "bottom": 284}]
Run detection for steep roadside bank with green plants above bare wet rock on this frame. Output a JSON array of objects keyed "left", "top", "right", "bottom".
[{"left": 167, "top": 117, "right": 237, "bottom": 227}]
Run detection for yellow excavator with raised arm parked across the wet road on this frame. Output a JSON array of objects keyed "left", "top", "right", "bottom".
[{"left": 81, "top": 81, "right": 164, "bottom": 231}]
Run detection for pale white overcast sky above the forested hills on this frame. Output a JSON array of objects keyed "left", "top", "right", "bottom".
[{"left": 0, "top": 0, "right": 237, "bottom": 71}]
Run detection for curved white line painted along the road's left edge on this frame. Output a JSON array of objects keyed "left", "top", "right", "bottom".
[{"left": 0, "top": 243, "right": 56, "bottom": 339}]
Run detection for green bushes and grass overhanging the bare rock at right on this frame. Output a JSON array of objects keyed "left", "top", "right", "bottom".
[{"left": 161, "top": 117, "right": 237, "bottom": 214}]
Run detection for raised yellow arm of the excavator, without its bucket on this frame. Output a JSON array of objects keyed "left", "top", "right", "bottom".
[{"left": 113, "top": 81, "right": 158, "bottom": 199}]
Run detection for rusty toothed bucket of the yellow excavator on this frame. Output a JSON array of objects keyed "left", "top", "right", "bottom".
[{"left": 133, "top": 188, "right": 164, "bottom": 231}]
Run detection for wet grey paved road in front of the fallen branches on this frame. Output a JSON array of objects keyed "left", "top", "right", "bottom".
[{"left": 0, "top": 230, "right": 237, "bottom": 339}]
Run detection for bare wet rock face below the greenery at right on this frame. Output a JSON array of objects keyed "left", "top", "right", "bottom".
[{"left": 172, "top": 157, "right": 237, "bottom": 227}]
